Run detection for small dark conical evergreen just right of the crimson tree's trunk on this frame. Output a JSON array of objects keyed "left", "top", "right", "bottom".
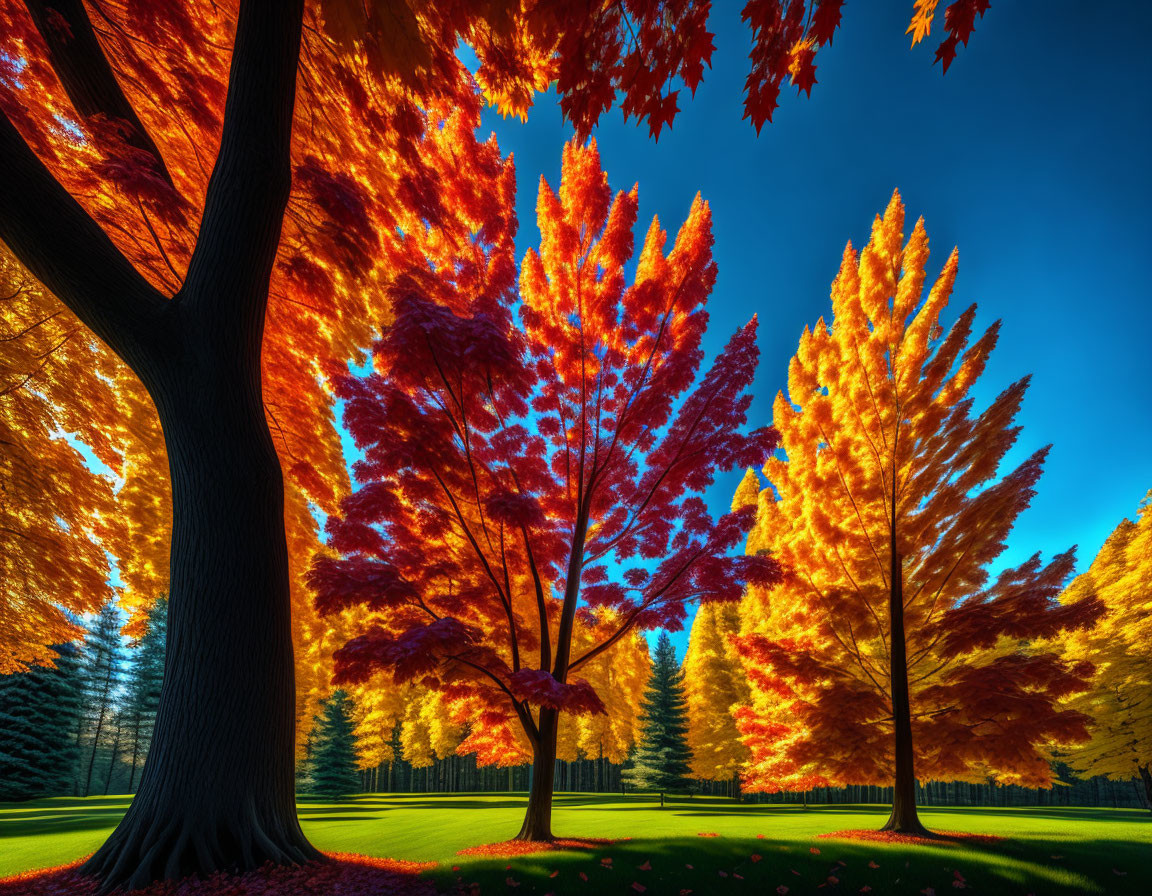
[{"left": 623, "top": 632, "right": 692, "bottom": 792}]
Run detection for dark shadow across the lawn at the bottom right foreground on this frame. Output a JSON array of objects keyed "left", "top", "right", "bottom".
[{"left": 434, "top": 837, "right": 1152, "bottom": 896}]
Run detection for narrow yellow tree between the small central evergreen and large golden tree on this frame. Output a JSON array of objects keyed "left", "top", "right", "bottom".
[{"left": 684, "top": 470, "right": 760, "bottom": 783}]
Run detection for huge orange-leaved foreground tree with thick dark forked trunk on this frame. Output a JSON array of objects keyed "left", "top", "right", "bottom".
[{"left": 0, "top": 0, "right": 990, "bottom": 886}]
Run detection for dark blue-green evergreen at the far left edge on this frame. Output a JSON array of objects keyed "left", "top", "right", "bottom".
[{"left": 0, "top": 644, "right": 82, "bottom": 802}]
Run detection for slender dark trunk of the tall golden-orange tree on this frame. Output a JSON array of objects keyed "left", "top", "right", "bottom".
[{"left": 881, "top": 541, "right": 927, "bottom": 834}]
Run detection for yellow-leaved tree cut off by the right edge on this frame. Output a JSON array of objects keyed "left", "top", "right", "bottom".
[{"left": 1060, "top": 493, "right": 1152, "bottom": 807}]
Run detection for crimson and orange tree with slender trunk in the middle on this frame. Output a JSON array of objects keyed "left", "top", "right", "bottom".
[{"left": 311, "top": 142, "right": 776, "bottom": 840}]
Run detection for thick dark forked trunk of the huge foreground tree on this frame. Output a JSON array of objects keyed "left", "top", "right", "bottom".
[{"left": 0, "top": 0, "right": 321, "bottom": 891}]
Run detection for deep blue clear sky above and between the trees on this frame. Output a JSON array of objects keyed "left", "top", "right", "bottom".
[{"left": 474, "top": 0, "right": 1152, "bottom": 653}]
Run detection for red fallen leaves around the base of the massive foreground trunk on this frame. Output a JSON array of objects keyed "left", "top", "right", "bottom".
[{"left": 0, "top": 852, "right": 437, "bottom": 896}]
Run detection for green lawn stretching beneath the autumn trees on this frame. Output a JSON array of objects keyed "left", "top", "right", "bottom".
[{"left": 0, "top": 794, "right": 1152, "bottom": 896}]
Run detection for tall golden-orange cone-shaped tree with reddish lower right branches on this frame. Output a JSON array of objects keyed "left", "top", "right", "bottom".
[{"left": 740, "top": 193, "right": 1098, "bottom": 833}]
